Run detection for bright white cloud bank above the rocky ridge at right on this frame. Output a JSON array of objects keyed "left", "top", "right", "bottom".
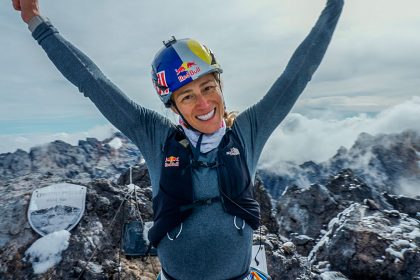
[{"left": 260, "top": 97, "right": 420, "bottom": 167}]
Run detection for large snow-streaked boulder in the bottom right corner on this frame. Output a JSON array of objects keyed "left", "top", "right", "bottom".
[{"left": 309, "top": 203, "right": 420, "bottom": 279}]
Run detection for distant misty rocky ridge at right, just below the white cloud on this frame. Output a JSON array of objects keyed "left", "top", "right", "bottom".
[{"left": 258, "top": 131, "right": 420, "bottom": 199}]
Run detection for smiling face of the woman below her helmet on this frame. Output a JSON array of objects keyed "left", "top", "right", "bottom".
[{"left": 172, "top": 73, "right": 225, "bottom": 134}]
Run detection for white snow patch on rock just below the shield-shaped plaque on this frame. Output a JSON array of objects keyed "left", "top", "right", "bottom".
[{"left": 25, "top": 230, "right": 70, "bottom": 274}]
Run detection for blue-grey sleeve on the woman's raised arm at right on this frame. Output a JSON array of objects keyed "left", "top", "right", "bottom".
[{"left": 235, "top": 0, "right": 344, "bottom": 174}]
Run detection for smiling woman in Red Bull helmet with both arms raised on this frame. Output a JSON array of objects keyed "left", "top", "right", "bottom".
[{"left": 13, "top": 0, "right": 343, "bottom": 280}]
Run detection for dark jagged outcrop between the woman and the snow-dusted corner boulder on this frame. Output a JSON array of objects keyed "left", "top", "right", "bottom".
[{"left": 276, "top": 169, "right": 393, "bottom": 255}]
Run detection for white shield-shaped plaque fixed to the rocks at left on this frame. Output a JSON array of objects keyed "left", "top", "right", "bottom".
[{"left": 28, "top": 183, "right": 86, "bottom": 236}]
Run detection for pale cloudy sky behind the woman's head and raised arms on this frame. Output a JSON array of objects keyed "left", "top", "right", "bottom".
[{"left": 0, "top": 0, "right": 420, "bottom": 161}]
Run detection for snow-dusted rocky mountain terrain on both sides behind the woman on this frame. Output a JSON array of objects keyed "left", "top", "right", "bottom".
[{"left": 0, "top": 132, "right": 420, "bottom": 280}]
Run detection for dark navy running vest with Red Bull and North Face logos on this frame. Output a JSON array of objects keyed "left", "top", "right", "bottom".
[{"left": 148, "top": 127, "right": 260, "bottom": 247}]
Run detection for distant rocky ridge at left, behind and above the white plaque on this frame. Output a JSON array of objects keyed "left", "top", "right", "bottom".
[{"left": 0, "top": 133, "right": 141, "bottom": 183}]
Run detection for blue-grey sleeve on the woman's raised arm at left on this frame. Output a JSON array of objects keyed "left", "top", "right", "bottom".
[{"left": 32, "top": 21, "right": 171, "bottom": 160}]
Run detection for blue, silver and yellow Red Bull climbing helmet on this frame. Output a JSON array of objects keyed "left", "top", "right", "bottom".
[{"left": 152, "top": 36, "right": 223, "bottom": 108}]
